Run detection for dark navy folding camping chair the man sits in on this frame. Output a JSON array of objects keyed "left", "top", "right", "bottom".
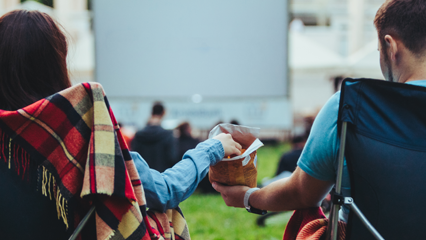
[{"left": 327, "top": 79, "right": 426, "bottom": 239}]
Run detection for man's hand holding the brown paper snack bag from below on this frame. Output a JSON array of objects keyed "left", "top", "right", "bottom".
[{"left": 212, "top": 182, "right": 250, "bottom": 208}]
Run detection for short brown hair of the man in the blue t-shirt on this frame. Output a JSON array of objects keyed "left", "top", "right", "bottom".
[{"left": 374, "top": 0, "right": 426, "bottom": 56}]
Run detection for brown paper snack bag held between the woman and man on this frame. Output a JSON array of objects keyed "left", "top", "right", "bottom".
[{"left": 209, "top": 123, "right": 263, "bottom": 187}]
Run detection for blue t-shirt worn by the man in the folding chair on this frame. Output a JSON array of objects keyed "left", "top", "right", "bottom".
[{"left": 297, "top": 80, "right": 426, "bottom": 220}]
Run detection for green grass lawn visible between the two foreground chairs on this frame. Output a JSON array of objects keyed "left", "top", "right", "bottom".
[{"left": 180, "top": 144, "right": 291, "bottom": 240}]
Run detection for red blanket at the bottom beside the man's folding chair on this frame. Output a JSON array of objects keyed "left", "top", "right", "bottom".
[{"left": 283, "top": 207, "right": 346, "bottom": 240}]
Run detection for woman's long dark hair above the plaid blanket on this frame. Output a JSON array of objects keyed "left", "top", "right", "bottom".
[{"left": 0, "top": 10, "right": 71, "bottom": 110}]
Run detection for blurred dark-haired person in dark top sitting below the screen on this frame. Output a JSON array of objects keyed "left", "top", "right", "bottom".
[{"left": 130, "top": 102, "right": 176, "bottom": 172}]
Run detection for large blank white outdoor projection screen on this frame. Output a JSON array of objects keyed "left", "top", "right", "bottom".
[{"left": 93, "top": 0, "right": 288, "bottom": 98}]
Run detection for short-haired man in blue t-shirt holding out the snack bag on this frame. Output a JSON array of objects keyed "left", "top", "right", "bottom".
[{"left": 213, "top": 0, "right": 426, "bottom": 219}]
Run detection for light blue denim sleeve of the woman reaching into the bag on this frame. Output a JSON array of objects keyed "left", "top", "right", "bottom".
[{"left": 130, "top": 139, "right": 225, "bottom": 212}]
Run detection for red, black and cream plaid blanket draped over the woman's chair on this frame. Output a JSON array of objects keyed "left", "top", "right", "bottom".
[{"left": 0, "top": 83, "right": 189, "bottom": 240}]
